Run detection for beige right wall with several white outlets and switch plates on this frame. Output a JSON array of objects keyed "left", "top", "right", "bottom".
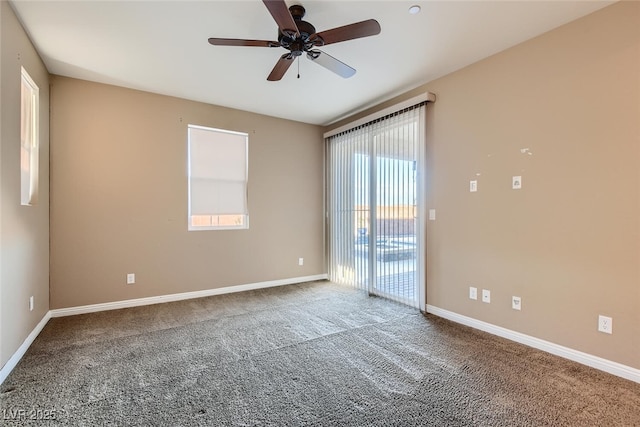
[{"left": 328, "top": 2, "right": 640, "bottom": 368}]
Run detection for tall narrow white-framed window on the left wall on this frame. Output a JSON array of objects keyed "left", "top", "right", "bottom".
[{"left": 20, "top": 68, "right": 40, "bottom": 206}]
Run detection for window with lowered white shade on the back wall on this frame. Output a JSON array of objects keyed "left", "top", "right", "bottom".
[{"left": 188, "top": 125, "right": 249, "bottom": 231}]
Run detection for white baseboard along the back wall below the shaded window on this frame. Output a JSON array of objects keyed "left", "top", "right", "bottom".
[{"left": 50, "top": 274, "right": 327, "bottom": 317}]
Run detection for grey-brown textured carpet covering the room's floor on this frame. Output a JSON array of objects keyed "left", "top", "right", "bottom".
[{"left": 0, "top": 282, "right": 640, "bottom": 426}]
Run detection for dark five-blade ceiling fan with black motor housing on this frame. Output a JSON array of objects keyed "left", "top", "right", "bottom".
[{"left": 209, "top": 0, "right": 380, "bottom": 81}]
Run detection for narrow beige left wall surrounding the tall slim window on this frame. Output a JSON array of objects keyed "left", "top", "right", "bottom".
[{"left": 0, "top": 1, "right": 49, "bottom": 367}]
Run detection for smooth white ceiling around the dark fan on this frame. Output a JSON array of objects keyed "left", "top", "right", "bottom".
[{"left": 12, "top": 0, "right": 613, "bottom": 124}]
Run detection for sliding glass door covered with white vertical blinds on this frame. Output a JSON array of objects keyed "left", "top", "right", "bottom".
[{"left": 328, "top": 105, "right": 424, "bottom": 308}]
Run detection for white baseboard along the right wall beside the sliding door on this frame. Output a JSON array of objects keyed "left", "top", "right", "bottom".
[{"left": 427, "top": 304, "right": 640, "bottom": 383}]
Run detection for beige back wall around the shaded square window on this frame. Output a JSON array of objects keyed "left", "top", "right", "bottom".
[{"left": 51, "top": 76, "right": 325, "bottom": 308}]
